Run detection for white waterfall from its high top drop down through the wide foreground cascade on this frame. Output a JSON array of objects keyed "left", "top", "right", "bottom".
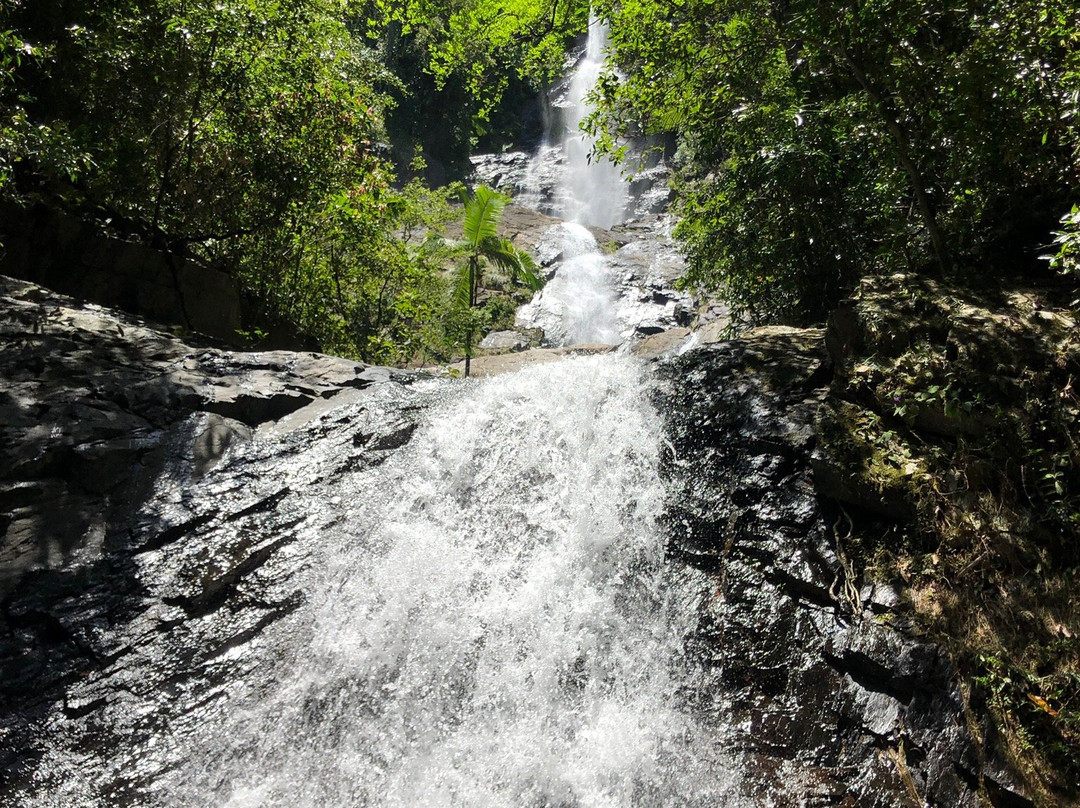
[{"left": 170, "top": 14, "right": 735, "bottom": 808}]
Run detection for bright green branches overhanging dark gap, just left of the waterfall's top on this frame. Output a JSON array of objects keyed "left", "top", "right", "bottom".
[{"left": 349, "top": 0, "right": 589, "bottom": 177}]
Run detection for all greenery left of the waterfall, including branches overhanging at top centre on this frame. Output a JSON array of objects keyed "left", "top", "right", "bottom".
[{"left": 0, "top": 0, "right": 585, "bottom": 363}]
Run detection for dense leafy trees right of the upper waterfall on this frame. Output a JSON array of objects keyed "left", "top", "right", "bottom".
[{"left": 592, "top": 0, "right": 1080, "bottom": 322}]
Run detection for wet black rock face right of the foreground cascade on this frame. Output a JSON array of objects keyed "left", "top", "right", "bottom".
[{"left": 658, "top": 328, "right": 1029, "bottom": 808}]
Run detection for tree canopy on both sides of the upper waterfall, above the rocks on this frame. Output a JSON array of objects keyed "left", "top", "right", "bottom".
[{"left": 0, "top": 0, "right": 1080, "bottom": 343}]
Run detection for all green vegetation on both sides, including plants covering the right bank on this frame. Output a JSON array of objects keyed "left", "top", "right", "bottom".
[{"left": 0, "top": 0, "right": 1080, "bottom": 802}]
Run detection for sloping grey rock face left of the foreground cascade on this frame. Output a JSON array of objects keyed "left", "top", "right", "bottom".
[{"left": 0, "top": 279, "right": 429, "bottom": 806}]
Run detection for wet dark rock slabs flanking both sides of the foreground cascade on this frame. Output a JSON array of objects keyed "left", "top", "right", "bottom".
[{"left": 0, "top": 267, "right": 1062, "bottom": 806}]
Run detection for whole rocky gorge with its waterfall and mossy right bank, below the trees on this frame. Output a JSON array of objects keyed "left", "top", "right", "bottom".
[{"left": 0, "top": 14, "right": 1080, "bottom": 808}]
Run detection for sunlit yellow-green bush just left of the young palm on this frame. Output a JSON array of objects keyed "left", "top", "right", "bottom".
[{"left": 242, "top": 180, "right": 464, "bottom": 364}]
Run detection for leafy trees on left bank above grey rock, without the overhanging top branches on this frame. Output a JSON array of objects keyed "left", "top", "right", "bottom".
[{"left": 0, "top": 0, "right": 488, "bottom": 362}]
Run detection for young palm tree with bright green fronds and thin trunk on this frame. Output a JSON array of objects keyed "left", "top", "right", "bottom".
[{"left": 454, "top": 186, "right": 543, "bottom": 378}]
